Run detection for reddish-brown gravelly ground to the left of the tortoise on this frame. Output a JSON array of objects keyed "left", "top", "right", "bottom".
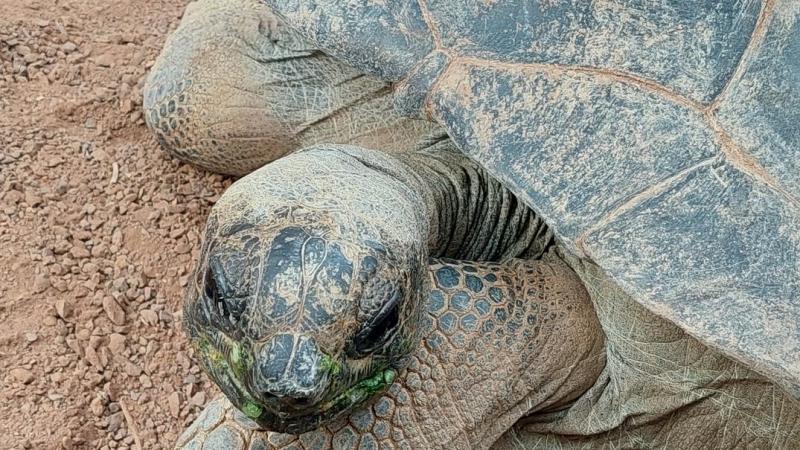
[{"left": 0, "top": 0, "right": 230, "bottom": 449}]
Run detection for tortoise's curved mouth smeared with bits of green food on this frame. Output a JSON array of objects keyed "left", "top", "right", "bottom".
[{"left": 192, "top": 332, "right": 399, "bottom": 434}]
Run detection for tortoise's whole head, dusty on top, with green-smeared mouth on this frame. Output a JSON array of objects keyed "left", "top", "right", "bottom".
[{"left": 184, "top": 146, "right": 428, "bottom": 434}]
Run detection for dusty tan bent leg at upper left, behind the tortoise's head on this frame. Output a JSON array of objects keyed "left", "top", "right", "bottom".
[{"left": 144, "top": 0, "right": 444, "bottom": 175}]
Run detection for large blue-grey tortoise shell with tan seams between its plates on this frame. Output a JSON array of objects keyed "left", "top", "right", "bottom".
[{"left": 265, "top": 0, "right": 800, "bottom": 397}]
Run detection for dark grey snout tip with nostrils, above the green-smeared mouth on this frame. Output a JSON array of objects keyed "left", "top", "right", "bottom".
[{"left": 253, "top": 334, "right": 330, "bottom": 412}]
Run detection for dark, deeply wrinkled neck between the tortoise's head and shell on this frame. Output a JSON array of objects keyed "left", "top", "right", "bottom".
[{"left": 316, "top": 141, "right": 553, "bottom": 261}]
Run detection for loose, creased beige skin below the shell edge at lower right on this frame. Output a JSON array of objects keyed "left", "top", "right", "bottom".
[{"left": 493, "top": 257, "right": 800, "bottom": 450}]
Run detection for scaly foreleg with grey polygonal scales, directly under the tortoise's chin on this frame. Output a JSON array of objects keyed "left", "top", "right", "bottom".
[{"left": 177, "top": 260, "right": 605, "bottom": 450}]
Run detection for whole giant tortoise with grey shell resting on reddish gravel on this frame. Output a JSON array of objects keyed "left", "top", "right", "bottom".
[{"left": 145, "top": 0, "right": 800, "bottom": 448}]
